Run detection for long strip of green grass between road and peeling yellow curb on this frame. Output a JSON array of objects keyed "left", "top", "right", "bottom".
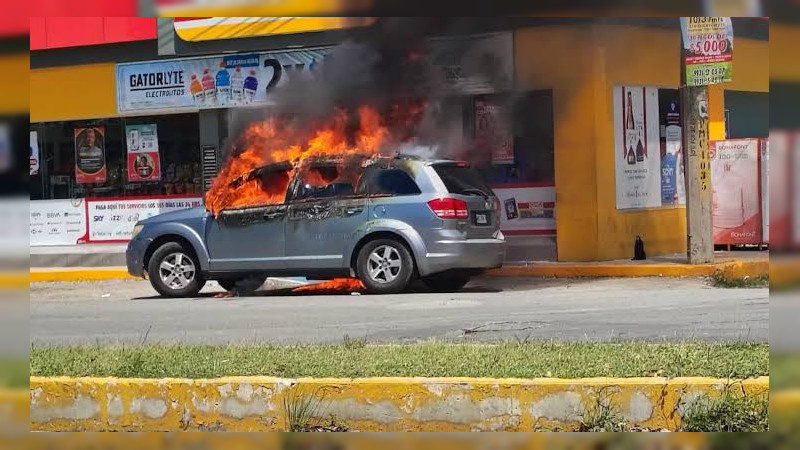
[{"left": 30, "top": 339, "right": 769, "bottom": 378}]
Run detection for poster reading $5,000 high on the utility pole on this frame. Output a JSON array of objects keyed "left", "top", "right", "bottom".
[{"left": 681, "top": 17, "right": 733, "bottom": 86}]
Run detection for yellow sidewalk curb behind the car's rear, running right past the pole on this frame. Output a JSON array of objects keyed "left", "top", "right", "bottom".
[{"left": 487, "top": 259, "right": 769, "bottom": 278}]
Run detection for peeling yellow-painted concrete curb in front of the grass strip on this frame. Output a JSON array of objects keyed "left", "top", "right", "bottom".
[{"left": 30, "top": 377, "right": 769, "bottom": 431}]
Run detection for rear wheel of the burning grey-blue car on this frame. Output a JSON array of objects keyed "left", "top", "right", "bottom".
[{"left": 356, "top": 239, "right": 414, "bottom": 294}]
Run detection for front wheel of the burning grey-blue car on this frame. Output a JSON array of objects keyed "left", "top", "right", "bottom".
[{"left": 147, "top": 242, "right": 206, "bottom": 297}]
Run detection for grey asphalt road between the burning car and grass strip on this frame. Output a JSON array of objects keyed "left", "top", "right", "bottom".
[{"left": 30, "top": 278, "right": 769, "bottom": 345}]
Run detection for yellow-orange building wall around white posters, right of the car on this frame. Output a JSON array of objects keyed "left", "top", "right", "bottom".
[{"left": 514, "top": 25, "right": 769, "bottom": 261}]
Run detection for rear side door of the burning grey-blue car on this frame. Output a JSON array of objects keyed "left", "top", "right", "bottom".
[{"left": 286, "top": 167, "right": 367, "bottom": 269}]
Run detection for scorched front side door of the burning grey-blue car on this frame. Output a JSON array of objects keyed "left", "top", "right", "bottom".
[{"left": 206, "top": 165, "right": 289, "bottom": 272}]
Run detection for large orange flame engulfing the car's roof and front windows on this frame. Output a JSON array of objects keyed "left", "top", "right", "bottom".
[{"left": 206, "top": 101, "right": 426, "bottom": 215}]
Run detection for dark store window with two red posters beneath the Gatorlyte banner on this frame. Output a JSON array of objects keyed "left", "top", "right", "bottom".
[{"left": 30, "top": 114, "right": 202, "bottom": 200}]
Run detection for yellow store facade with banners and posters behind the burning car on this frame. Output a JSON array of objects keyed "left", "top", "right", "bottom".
[{"left": 31, "top": 19, "right": 769, "bottom": 262}]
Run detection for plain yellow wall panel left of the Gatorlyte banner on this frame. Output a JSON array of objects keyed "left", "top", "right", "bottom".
[{"left": 30, "top": 63, "right": 118, "bottom": 123}]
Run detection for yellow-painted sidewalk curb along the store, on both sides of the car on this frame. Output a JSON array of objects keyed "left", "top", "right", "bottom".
[{"left": 29, "top": 259, "right": 771, "bottom": 286}]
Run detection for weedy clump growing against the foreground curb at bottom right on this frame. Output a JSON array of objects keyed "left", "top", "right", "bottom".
[{"left": 681, "top": 384, "right": 769, "bottom": 433}]
